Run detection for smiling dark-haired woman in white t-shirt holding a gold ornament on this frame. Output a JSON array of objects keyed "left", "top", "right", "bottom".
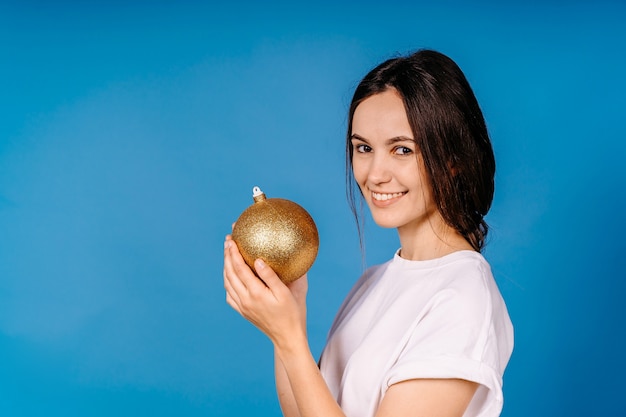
[{"left": 224, "top": 50, "right": 513, "bottom": 417}]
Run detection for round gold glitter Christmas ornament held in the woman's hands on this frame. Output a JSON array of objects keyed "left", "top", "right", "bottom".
[{"left": 232, "top": 187, "right": 319, "bottom": 283}]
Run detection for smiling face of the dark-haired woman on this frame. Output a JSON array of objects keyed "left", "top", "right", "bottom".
[{"left": 351, "top": 89, "right": 437, "bottom": 228}]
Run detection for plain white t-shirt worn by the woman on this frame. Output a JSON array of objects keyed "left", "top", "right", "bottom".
[{"left": 320, "top": 251, "right": 513, "bottom": 417}]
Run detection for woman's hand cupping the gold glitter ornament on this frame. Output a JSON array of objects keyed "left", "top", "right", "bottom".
[{"left": 224, "top": 236, "right": 307, "bottom": 348}]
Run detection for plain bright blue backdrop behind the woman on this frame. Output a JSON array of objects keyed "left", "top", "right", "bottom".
[{"left": 0, "top": 0, "right": 626, "bottom": 417}]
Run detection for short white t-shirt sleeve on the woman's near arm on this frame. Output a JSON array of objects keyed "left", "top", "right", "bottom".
[{"left": 383, "top": 278, "right": 503, "bottom": 416}]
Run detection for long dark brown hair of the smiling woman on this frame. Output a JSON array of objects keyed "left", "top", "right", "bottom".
[{"left": 346, "top": 50, "right": 495, "bottom": 252}]
